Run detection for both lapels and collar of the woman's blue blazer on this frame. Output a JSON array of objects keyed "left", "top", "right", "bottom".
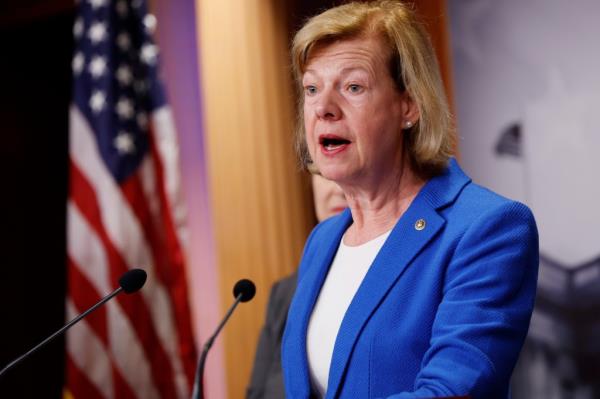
[{"left": 295, "top": 159, "right": 470, "bottom": 398}]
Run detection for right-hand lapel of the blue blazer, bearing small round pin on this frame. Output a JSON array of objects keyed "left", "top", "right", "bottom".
[{"left": 326, "top": 161, "right": 469, "bottom": 398}]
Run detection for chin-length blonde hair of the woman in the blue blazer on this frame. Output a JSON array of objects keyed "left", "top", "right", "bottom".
[{"left": 291, "top": 0, "right": 455, "bottom": 176}]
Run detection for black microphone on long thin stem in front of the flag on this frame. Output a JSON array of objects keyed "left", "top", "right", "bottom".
[{"left": 0, "top": 269, "right": 147, "bottom": 377}]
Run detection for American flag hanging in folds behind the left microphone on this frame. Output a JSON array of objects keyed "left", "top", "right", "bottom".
[{"left": 66, "top": 0, "right": 196, "bottom": 399}]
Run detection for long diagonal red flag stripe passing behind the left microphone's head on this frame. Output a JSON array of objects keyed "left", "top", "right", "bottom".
[{"left": 70, "top": 162, "right": 177, "bottom": 399}]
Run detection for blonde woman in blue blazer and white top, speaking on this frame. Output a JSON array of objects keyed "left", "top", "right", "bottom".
[{"left": 282, "top": 1, "right": 538, "bottom": 399}]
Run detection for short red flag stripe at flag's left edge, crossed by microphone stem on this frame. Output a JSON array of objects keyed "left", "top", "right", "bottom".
[{"left": 67, "top": 256, "right": 109, "bottom": 347}]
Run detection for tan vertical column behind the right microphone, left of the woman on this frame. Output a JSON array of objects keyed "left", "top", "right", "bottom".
[{"left": 196, "top": 0, "right": 313, "bottom": 398}]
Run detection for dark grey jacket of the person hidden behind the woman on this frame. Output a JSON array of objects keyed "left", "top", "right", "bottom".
[{"left": 246, "top": 273, "right": 297, "bottom": 399}]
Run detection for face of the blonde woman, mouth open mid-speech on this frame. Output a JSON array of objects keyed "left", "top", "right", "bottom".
[{"left": 302, "top": 37, "right": 415, "bottom": 185}]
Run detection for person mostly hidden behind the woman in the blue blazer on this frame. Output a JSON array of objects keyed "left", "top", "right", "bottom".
[{"left": 246, "top": 173, "right": 347, "bottom": 399}]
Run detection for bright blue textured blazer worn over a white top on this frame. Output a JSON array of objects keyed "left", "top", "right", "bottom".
[{"left": 282, "top": 160, "right": 539, "bottom": 399}]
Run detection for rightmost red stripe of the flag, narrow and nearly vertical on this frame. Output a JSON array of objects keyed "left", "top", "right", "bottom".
[{"left": 149, "top": 123, "right": 197, "bottom": 387}]
